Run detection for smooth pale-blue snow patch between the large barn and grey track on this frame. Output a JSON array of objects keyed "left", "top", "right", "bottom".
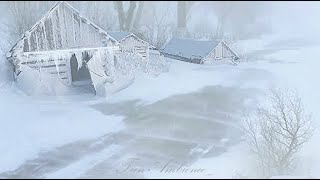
[{"left": 0, "top": 86, "right": 123, "bottom": 172}]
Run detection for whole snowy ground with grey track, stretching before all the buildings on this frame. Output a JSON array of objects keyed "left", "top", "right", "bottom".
[{"left": 0, "top": 33, "right": 320, "bottom": 178}]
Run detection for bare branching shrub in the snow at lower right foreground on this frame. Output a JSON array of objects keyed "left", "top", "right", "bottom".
[{"left": 242, "top": 90, "right": 313, "bottom": 177}]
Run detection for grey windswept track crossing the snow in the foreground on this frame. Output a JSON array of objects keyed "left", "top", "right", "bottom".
[{"left": 0, "top": 86, "right": 260, "bottom": 178}]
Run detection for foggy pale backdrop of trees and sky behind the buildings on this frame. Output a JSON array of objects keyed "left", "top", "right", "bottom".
[{"left": 0, "top": 1, "right": 320, "bottom": 50}]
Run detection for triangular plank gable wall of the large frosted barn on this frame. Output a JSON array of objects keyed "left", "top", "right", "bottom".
[{"left": 23, "top": 3, "right": 115, "bottom": 52}]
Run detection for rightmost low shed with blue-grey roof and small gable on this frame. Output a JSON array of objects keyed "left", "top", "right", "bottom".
[{"left": 160, "top": 38, "right": 239, "bottom": 64}]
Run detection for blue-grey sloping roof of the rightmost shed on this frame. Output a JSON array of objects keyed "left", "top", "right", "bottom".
[{"left": 161, "top": 38, "right": 221, "bottom": 59}]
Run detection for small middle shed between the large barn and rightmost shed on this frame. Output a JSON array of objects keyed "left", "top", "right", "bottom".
[{"left": 108, "top": 31, "right": 156, "bottom": 60}]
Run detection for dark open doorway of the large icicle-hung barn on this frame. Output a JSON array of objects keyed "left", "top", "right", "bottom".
[{"left": 70, "top": 55, "right": 95, "bottom": 93}]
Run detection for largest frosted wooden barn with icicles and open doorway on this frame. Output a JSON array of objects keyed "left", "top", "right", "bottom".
[{"left": 7, "top": 1, "right": 121, "bottom": 91}]
